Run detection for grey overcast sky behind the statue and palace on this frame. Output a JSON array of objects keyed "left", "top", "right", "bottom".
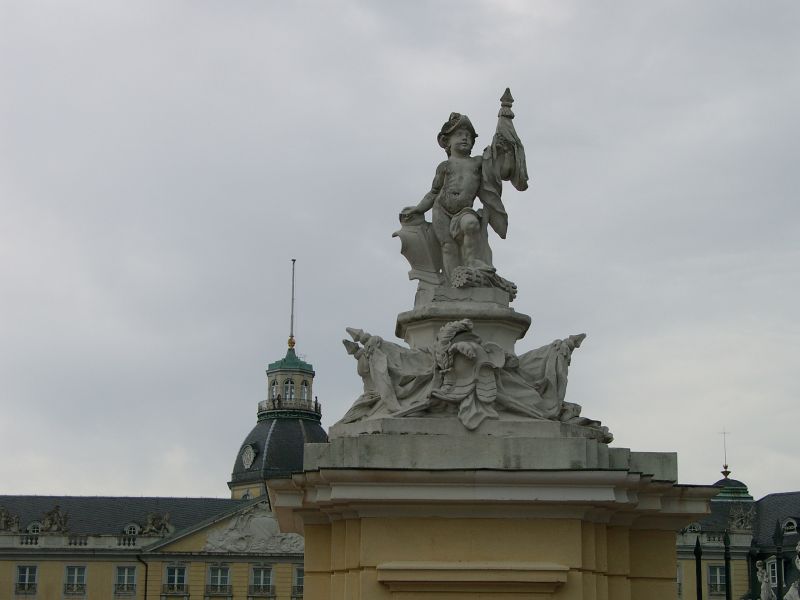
[{"left": 0, "top": 0, "right": 800, "bottom": 497}]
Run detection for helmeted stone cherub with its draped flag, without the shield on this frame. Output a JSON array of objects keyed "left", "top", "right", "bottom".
[{"left": 400, "top": 90, "right": 528, "bottom": 284}]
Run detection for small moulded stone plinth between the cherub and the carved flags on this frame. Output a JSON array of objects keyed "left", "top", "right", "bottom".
[{"left": 395, "top": 298, "right": 531, "bottom": 354}]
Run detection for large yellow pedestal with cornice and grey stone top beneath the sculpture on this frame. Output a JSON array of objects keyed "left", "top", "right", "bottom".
[{"left": 269, "top": 419, "right": 716, "bottom": 600}]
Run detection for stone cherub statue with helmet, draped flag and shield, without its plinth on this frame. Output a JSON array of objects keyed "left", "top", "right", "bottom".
[{"left": 396, "top": 89, "right": 528, "bottom": 296}]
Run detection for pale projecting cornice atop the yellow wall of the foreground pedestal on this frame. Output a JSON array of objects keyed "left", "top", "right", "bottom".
[{"left": 269, "top": 469, "right": 716, "bottom": 532}]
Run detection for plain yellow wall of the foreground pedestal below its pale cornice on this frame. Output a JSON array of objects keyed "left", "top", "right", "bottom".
[{"left": 305, "top": 518, "right": 676, "bottom": 600}]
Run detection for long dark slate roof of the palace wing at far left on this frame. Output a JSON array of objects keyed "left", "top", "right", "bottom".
[{"left": 0, "top": 496, "right": 246, "bottom": 535}]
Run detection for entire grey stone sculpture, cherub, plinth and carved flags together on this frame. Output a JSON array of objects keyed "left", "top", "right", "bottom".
[{"left": 341, "top": 89, "right": 611, "bottom": 441}]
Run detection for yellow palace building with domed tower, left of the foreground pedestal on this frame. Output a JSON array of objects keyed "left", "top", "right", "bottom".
[{"left": 0, "top": 335, "right": 327, "bottom": 600}]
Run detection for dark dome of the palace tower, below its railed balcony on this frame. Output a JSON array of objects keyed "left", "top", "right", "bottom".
[{"left": 230, "top": 410, "right": 328, "bottom": 484}]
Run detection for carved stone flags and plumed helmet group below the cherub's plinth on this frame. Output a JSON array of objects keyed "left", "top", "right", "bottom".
[{"left": 342, "top": 319, "right": 611, "bottom": 441}]
